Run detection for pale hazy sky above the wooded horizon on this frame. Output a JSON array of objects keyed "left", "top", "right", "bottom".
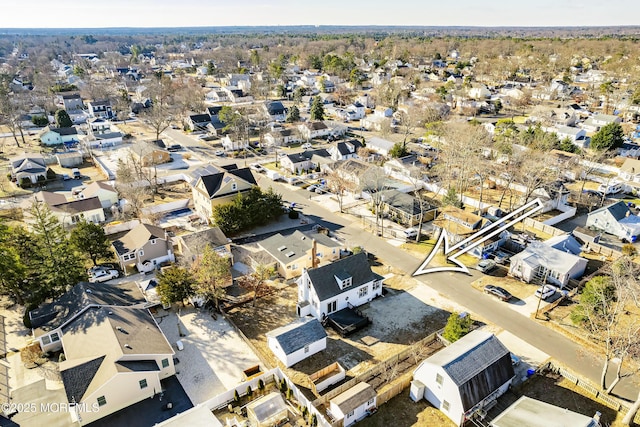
[{"left": 0, "top": 0, "right": 640, "bottom": 28}]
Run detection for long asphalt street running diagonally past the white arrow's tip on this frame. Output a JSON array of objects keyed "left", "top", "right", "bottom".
[{"left": 258, "top": 176, "right": 639, "bottom": 401}]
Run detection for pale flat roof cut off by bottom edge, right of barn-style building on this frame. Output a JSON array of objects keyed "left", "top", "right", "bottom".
[{"left": 489, "top": 396, "right": 601, "bottom": 427}]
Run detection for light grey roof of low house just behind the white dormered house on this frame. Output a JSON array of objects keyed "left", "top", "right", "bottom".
[{"left": 258, "top": 230, "right": 340, "bottom": 264}]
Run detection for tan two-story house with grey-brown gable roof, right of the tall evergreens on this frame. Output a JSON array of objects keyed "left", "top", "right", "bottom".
[{"left": 112, "top": 224, "right": 175, "bottom": 272}]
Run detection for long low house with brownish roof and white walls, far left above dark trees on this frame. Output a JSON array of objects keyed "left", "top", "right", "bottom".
[{"left": 22, "top": 191, "right": 105, "bottom": 227}]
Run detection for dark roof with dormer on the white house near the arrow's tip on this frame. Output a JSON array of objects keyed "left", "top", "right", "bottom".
[{"left": 307, "top": 253, "right": 382, "bottom": 301}]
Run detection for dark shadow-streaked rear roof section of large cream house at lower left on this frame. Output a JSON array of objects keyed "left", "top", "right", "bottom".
[{"left": 29, "top": 282, "right": 145, "bottom": 335}]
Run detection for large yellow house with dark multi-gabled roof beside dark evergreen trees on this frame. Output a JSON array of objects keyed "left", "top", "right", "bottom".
[{"left": 191, "top": 168, "right": 257, "bottom": 221}]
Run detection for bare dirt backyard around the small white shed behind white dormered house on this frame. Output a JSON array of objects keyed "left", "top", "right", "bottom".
[{"left": 227, "top": 284, "right": 449, "bottom": 398}]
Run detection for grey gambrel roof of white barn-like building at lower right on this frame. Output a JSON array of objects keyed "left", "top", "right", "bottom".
[{"left": 416, "top": 329, "right": 515, "bottom": 411}]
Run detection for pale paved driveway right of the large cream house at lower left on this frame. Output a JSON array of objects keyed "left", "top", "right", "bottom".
[{"left": 156, "top": 307, "right": 260, "bottom": 405}]
